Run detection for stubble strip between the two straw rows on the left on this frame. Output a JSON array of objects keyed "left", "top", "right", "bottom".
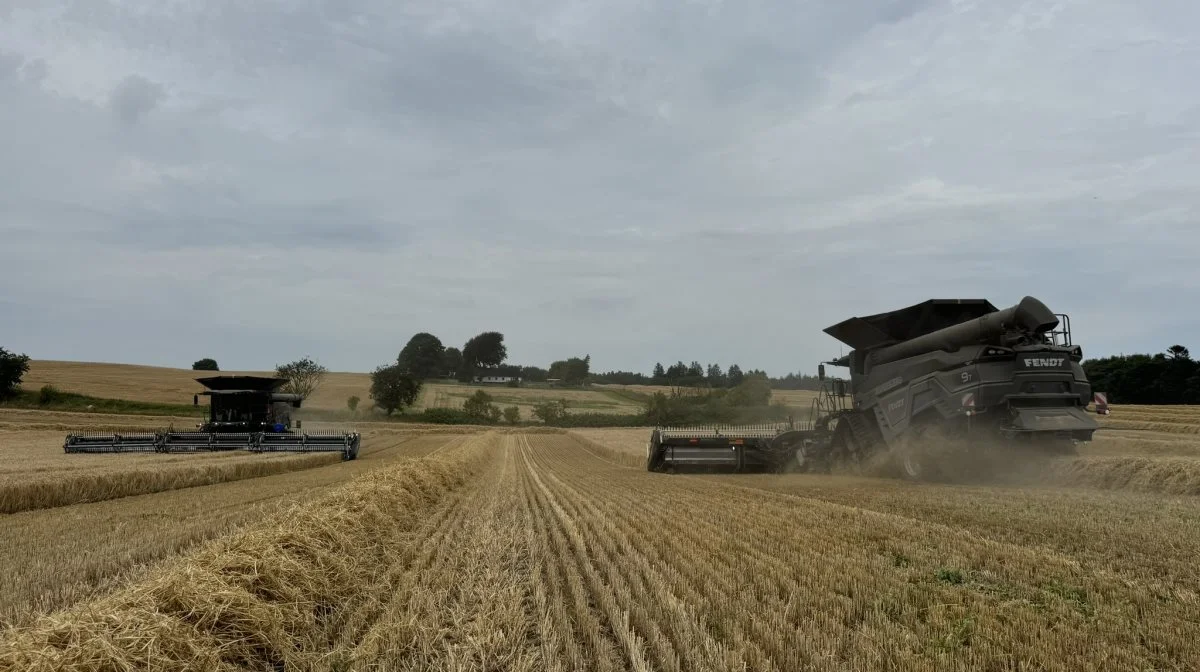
[{"left": 0, "top": 432, "right": 466, "bottom": 625}]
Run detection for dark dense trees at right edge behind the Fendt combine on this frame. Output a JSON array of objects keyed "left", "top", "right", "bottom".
[{"left": 1082, "top": 344, "right": 1200, "bottom": 404}]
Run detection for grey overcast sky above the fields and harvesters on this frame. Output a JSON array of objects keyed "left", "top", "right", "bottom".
[{"left": 0, "top": 0, "right": 1200, "bottom": 373}]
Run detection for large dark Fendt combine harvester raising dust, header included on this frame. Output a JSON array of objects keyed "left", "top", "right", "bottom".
[{"left": 647, "top": 296, "right": 1108, "bottom": 479}]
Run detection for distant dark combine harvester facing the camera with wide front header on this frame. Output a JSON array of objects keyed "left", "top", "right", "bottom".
[{"left": 64, "top": 376, "right": 360, "bottom": 460}]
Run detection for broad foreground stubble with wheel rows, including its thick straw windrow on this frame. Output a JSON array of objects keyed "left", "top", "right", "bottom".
[{"left": 0, "top": 432, "right": 1200, "bottom": 671}]
